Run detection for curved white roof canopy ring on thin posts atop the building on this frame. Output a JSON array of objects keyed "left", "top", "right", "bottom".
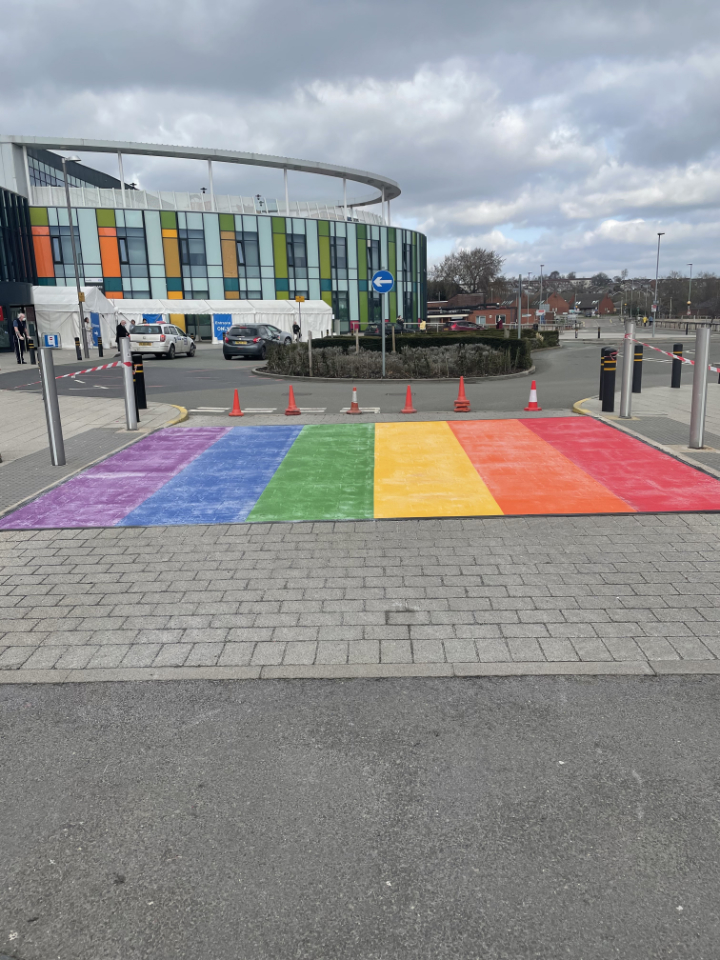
[{"left": 0, "top": 135, "right": 401, "bottom": 207}]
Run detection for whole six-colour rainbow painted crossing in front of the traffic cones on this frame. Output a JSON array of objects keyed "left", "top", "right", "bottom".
[{"left": 0, "top": 417, "right": 720, "bottom": 530}]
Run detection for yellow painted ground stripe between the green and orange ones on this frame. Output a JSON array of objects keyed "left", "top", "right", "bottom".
[{"left": 375, "top": 420, "right": 502, "bottom": 518}]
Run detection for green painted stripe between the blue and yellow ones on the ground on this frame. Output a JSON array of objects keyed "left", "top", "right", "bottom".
[{"left": 248, "top": 423, "right": 375, "bottom": 521}]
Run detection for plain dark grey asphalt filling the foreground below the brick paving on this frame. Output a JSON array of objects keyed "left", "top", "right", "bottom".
[{"left": 0, "top": 677, "right": 720, "bottom": 960}]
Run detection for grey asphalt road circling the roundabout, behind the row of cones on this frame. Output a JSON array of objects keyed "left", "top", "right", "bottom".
[{"left": 0, "top": 337, "right": 704, "bottom": 413}]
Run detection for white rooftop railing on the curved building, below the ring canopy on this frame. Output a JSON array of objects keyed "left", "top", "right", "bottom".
[{"left": 30, "top": 186, "right": 383, "bottom": 224}]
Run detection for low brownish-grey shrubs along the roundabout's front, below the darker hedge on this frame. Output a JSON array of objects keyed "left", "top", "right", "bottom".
[{"left": 267, "top": 341, "right": 524, "bottom": 380}]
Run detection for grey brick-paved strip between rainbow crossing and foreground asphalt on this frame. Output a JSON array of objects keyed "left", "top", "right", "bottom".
[{"left": 0, "top": 514, "right": 720, "bottom": 682}]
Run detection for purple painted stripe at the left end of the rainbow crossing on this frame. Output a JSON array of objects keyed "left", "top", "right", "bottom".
[{"left": 0, "top": 427, "right": 230, "bottom": 530}]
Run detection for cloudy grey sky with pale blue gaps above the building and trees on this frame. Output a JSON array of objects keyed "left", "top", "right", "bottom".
[{"left": 0, "top": 0, "right": 720, "bottom": 276}]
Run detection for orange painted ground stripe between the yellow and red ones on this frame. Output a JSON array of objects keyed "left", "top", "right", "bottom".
[{"left": 449, "top": 420, "right": 635, "bottom": 514}]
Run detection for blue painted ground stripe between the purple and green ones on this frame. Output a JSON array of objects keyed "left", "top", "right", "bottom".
[{"left": 118, "top": 426, "right": 302, "bottom": 527}]
